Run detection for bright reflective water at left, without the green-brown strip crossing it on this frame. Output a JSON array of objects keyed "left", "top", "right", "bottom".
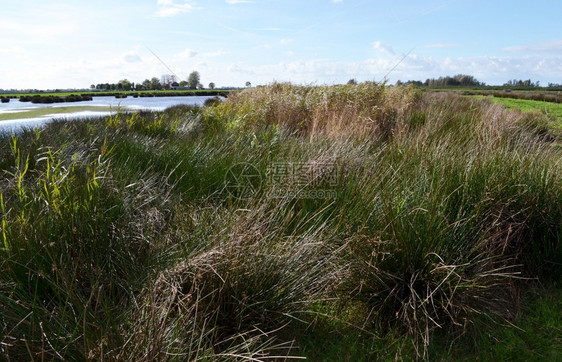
[{"left": 0, "top": 96, "right": 213, "bottom": 133}]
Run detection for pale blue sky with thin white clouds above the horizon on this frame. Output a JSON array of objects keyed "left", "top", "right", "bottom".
[{"left": 0, "top": 0, "right": 562, "bottom": 89}]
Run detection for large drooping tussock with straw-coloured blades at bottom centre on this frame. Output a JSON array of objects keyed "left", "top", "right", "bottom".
[{"left": 118, "top": 205, "right": 334, "bottom": 360}]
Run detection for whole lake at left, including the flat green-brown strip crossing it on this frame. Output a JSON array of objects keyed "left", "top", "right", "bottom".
[{"left": 0, "top": 96, "right": 213, "bottom": 133}]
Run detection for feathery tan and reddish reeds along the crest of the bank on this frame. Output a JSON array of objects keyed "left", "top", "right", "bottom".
[{"left": 203, "top": 82, "right": 416, "bottom": 139}]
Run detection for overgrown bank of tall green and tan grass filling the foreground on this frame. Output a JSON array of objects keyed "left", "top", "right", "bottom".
[{"left": 0, "top": 83, "right": 562, "bottom": 360}]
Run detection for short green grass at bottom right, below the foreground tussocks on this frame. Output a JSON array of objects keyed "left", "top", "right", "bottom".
[{"left": 290, "top": 286, "right": 562, "bottom": 361}]
